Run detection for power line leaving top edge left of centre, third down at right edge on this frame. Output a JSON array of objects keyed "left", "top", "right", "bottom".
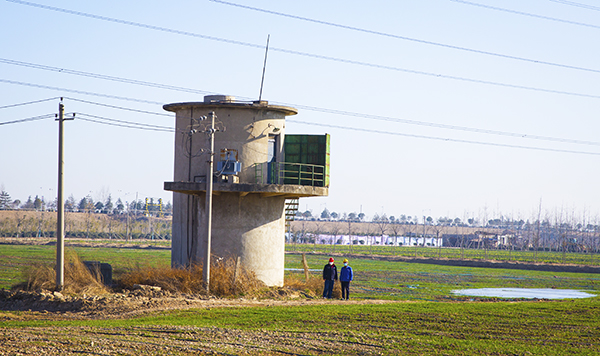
[{"left": 209, "top": 0, "right": 600, "bottom": 73}]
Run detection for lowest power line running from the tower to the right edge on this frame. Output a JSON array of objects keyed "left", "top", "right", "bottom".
[{"left": 288, "top": 119, "right": 600, "bottom": 156}]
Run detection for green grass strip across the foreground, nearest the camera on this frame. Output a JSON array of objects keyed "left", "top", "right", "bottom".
[{"left": 0, "top": 298, "right": 600, "bottom": 355}]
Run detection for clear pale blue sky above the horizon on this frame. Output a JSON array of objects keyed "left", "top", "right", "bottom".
[{"left": 0, "top": 0, "right": 600, "bottom": 219}]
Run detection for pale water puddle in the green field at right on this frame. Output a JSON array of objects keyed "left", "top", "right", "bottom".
[{"left": 452, "top": 288, "right": 596, "bottom": 299}]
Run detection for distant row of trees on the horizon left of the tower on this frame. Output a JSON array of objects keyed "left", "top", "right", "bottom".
[{"left": 0, "top": 189, "right": 173, "bottom": 216}]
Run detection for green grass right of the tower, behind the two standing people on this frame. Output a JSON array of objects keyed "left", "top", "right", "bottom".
[{"left": 286, "top": 254, "right": 600, "bottom": 301}]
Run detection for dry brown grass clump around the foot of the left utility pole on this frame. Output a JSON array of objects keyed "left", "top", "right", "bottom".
[{"left": 13, "top": 251, "right": 108, "bottom": 295}]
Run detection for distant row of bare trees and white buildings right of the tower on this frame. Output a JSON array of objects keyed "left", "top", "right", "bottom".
[{"left": 288, "top": 211, "right": 600, "bottom": 253}]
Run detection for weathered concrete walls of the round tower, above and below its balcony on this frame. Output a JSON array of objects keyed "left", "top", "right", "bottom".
[{"left": 165, "top": 102, "right": 296, "bottom": 286}]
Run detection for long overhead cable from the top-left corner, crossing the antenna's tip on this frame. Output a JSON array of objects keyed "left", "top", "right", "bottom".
[{"left": 6, "top": 0, "right": 600, "bottom": 99}]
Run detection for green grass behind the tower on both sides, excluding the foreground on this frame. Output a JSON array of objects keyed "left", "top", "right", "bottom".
[{"left": 0, "top": 245, "right": 600, "bottom": 301}]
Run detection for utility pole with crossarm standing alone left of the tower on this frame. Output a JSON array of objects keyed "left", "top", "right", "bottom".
[{"left": 56, "top": 98, "right": 75, "bottom": 291}]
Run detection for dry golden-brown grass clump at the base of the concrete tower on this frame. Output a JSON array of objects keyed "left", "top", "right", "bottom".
[{"left": 118, "top": 258, "right": 265, "bottom": 297}]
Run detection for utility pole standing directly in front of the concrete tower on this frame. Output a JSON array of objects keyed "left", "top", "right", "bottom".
[{"left": 203, "top": 111, "right": 216, "bottom": 292}]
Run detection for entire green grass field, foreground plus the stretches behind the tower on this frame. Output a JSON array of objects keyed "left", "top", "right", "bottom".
[{"left": 0, "top": 241, "right": 600, "bottom": 355}]
